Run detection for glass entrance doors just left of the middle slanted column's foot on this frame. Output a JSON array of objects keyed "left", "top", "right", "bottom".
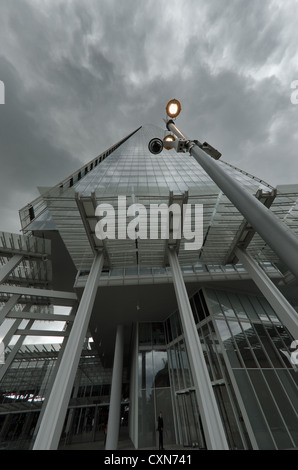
[{"left": 176, "top": 389, "right": 206, "bottom": 449}]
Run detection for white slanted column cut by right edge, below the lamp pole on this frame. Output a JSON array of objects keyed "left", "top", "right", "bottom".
[{"left": 235, "top": 248, "right": 298, "bottom": 338}]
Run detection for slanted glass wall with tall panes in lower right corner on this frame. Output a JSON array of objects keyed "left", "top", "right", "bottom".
[{"left": 205, "top": 289, "right": 298, "bottom": 449}]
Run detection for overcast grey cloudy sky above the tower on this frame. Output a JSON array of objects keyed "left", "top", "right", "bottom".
[{"left": 0, "top": 0, "right": 298, "bottom": 232}]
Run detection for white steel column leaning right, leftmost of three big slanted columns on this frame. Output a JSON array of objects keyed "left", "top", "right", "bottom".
[{"left": 33, "top": 252, "right": 104, "bottom": 450}]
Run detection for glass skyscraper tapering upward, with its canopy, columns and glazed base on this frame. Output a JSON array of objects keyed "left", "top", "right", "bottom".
[{"left": 0, "top": 125, "right": 298, "bottom": 449}]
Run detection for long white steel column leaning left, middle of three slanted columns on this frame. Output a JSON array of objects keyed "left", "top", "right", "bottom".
[{"left": 168, "top": 249, "right": 229, "bottom": 450}]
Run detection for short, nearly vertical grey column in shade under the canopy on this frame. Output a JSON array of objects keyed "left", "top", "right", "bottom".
[{"left": 105, "top": 325, "right": 124, "bottom": 450}]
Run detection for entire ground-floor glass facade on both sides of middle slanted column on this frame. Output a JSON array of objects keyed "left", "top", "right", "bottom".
[{"left": 144, "top": 289, "right": 298, "bottom": 449}]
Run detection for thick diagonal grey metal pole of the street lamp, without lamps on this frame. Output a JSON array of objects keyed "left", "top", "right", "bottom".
[{"left": 167, "top": 121, "right": 298, "bottom": 278}]
